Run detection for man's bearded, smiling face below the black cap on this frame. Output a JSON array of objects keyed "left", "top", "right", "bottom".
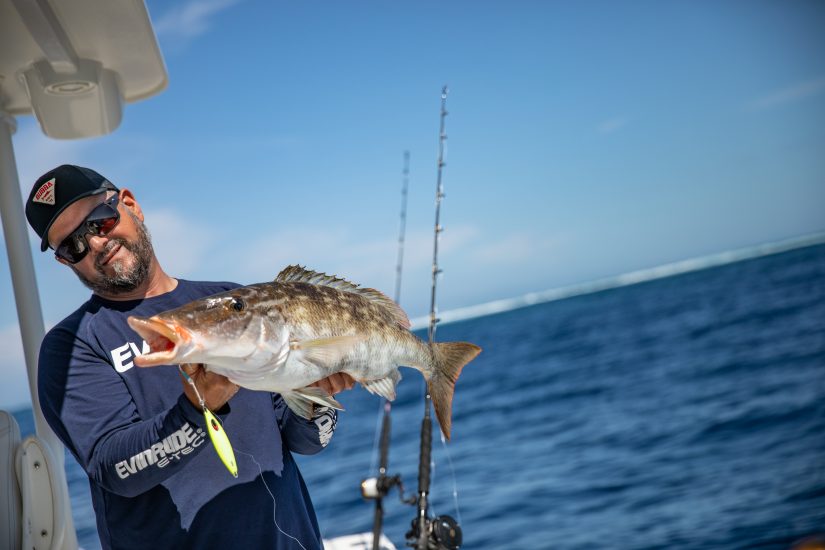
[{"left": 49, "top": 191, "right": 154, "bottom": 297}]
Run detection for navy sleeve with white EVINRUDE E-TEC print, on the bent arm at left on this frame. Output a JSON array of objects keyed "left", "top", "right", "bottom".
[{"left": 38, "top": 326, "right": 208, "bottom": 497}]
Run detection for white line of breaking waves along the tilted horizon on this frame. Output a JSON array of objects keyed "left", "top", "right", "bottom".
[{"left": 411, "top": 233, "right": 825, "bottom": 330}]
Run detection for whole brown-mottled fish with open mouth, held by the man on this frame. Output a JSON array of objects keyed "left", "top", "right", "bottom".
[{"left": 127, "top": 265, "right": 481, "bottom": 439}]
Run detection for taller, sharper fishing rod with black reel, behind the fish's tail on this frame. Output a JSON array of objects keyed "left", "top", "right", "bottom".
[{"left": 407, "top": 86, "right": 462, "bottom": 550}]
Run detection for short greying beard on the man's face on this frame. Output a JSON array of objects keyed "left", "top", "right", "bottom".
[{"left": 71, "top": 210, "right": 154, "bottom": 295}]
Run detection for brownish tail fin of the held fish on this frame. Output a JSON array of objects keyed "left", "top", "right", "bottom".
[{"left": 427, "top": 342, "right": 481, "bottom": 439}]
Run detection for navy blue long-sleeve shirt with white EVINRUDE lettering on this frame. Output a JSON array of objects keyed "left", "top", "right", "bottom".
[{"left": 38, "top": 280, "right": 336, "bottom": 550}]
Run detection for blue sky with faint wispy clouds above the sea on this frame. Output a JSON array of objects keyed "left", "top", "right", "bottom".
[{"left": 0, "top": 0, "right": 825, "bottom": 409}]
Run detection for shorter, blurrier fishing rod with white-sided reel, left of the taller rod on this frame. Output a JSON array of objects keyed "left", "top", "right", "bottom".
[{"left": 361, "top": 151, "right": 415, "bottom": 550}]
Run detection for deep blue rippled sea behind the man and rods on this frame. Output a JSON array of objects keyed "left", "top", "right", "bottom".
[{"left": 16, "top": 244, "right": 825, "bottom": 549}]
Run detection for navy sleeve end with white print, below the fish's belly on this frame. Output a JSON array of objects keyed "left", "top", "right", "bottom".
[{"left": 272, "top": 393, "right": 338, "bottom": 455}]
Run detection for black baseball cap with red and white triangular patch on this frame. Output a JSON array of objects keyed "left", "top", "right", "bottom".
[{"left": 26, "top": 164, "right": 118, "bottom": 252}]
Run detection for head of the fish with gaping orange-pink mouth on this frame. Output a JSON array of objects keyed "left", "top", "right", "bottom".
[{"left": 127, "top": 287, "right": 289, "bottom": 367}]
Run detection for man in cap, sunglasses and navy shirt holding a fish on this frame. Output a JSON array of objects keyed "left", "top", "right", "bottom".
[{"left": 26, "top": 165, "right": 353, "bottom": 550}]
